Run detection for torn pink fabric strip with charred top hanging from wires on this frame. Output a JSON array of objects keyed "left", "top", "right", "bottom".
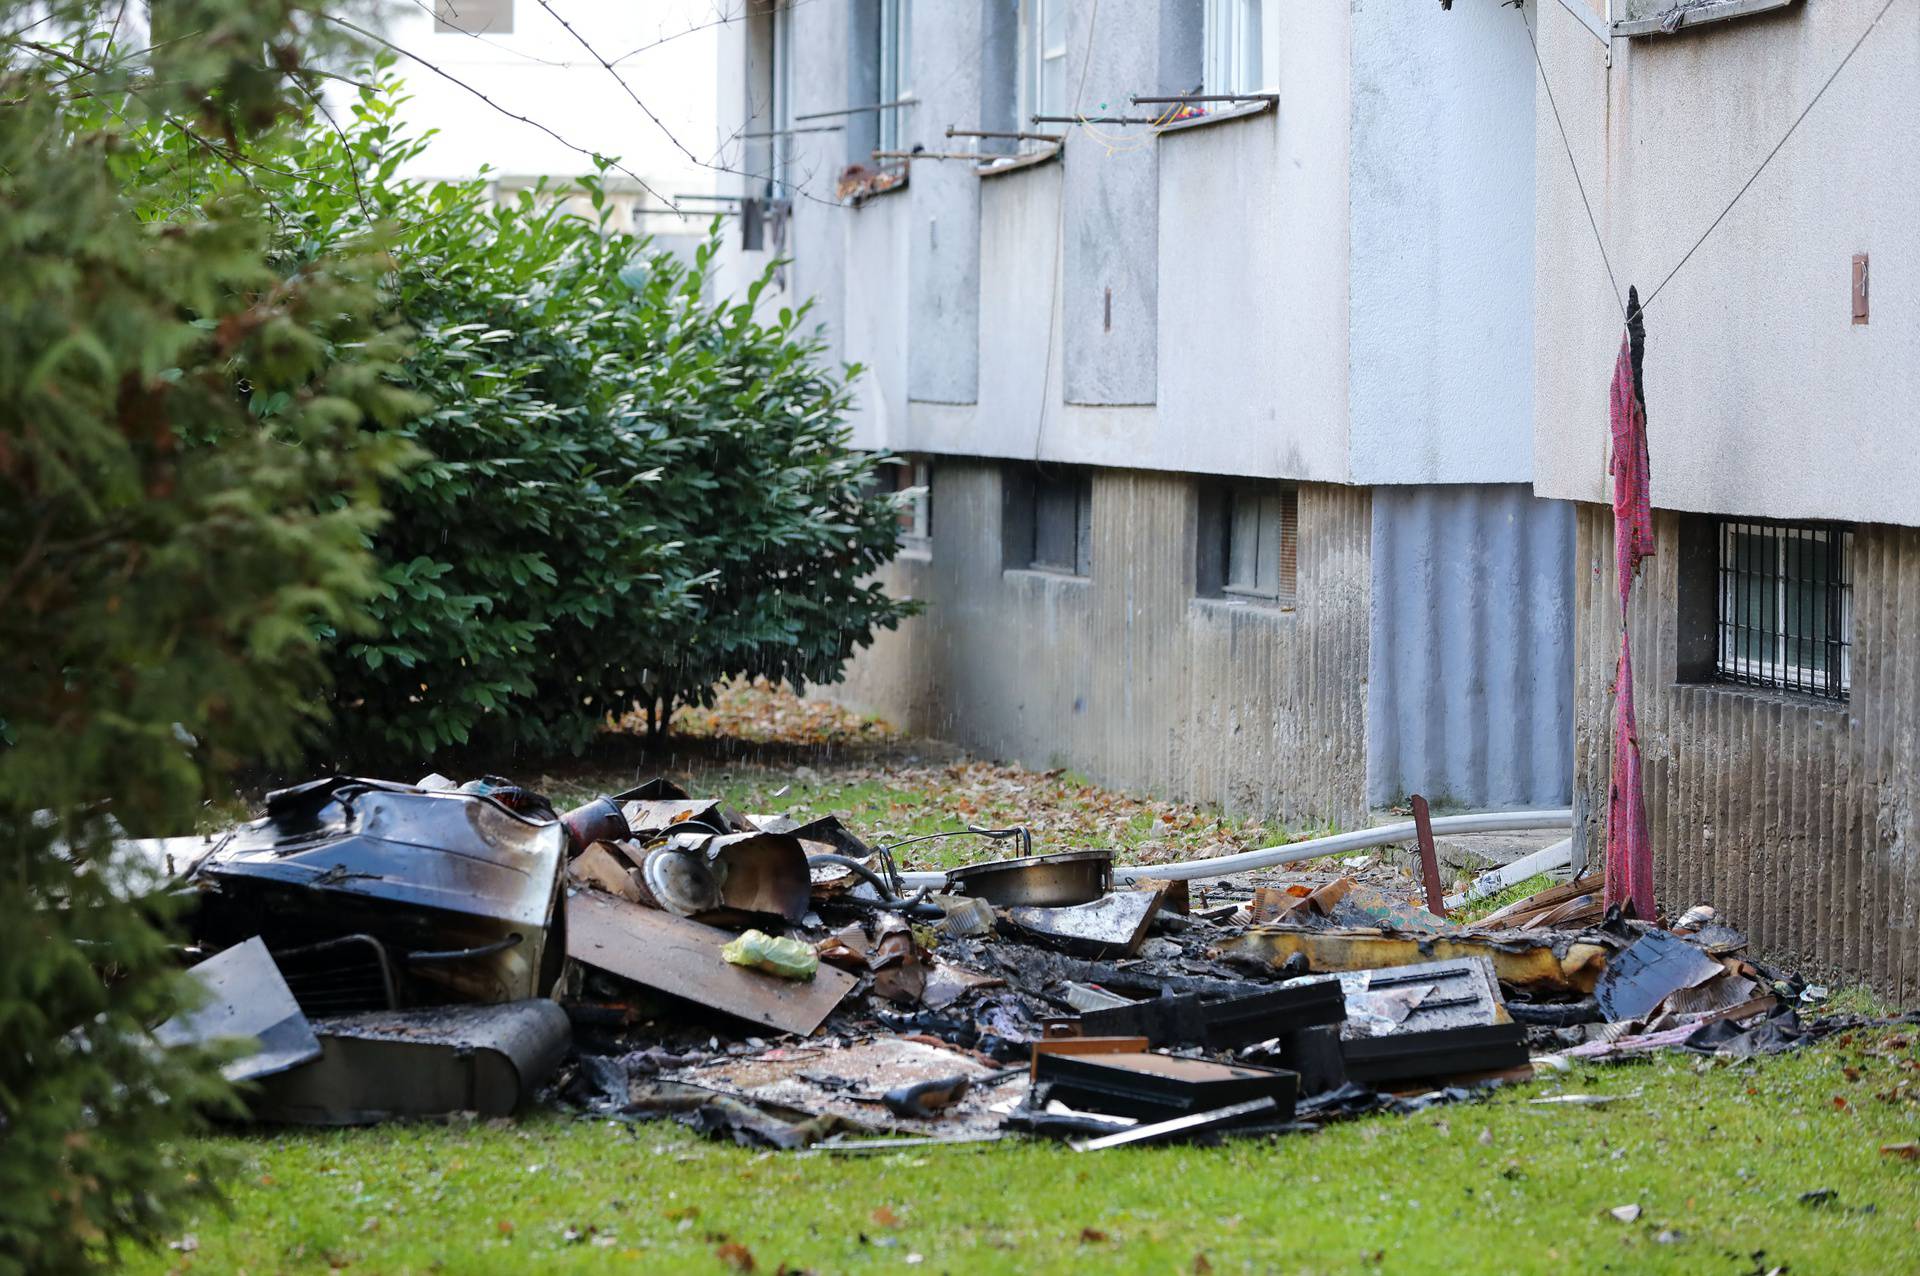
[{"left": 1607, "top": 288, "right": 1655, "bottom": 921}]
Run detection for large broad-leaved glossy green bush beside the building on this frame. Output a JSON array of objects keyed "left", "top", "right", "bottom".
[{"left": 255, "top": 84, "right": 906, "bottom": 766}]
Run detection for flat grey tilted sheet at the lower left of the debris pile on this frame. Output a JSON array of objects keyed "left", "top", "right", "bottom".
[{"left": 154, "top": 934, "right": 321, "bottom": 1082}]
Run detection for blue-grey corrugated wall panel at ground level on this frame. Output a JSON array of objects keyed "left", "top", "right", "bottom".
[{"left": 1367, "top": 484, "right": 1574, "bottom": 808}]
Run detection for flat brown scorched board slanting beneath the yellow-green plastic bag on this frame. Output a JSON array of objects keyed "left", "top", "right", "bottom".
[{"left": 566, "top": 890, "right": 858, "bottom": 1036}]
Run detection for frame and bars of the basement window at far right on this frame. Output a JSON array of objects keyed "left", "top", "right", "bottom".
[{"left": 1713, "top": 518, "right": 1855, "bottom": 702}]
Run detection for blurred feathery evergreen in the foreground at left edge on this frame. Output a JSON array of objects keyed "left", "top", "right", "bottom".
[{"left": 0, "top": 0, "right": 419, "bottom": 1272}]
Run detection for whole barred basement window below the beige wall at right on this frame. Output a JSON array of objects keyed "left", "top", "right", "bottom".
[{"left": 1715, "top": 518, "right": 1853, "bottom": 700}]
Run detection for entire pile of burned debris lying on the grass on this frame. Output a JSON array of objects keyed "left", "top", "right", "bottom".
[{"left": 134, "top": 775, "right": 1873, "bottom": 1153}]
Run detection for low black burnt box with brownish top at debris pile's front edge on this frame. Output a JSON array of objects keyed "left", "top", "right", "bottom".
[{"left": 1033, "top": 1053, "right": 1300, "bottom": 1121}]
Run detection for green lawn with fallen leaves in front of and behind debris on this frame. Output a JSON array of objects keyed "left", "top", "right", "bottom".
[{"left": 153, "top": 700, "right": 1920, "bottom": 1276}]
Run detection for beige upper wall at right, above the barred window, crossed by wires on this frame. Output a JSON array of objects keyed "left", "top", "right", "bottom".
[{"left": 1526, "top": 0, "right": 1920, "bottom": 525}]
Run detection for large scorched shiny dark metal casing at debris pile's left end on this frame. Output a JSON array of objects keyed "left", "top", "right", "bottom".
[{"left": 194, "top": 777, "right": 566, "bottom": 1002}]
